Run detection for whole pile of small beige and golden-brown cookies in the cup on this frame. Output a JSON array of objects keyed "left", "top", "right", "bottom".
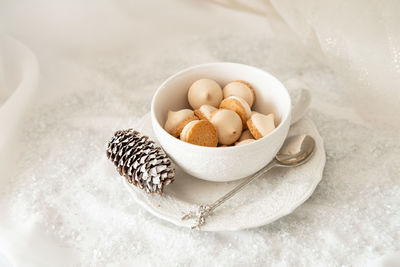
[{"left": 164, "top": 79, "right": 275, "bottom": 147}]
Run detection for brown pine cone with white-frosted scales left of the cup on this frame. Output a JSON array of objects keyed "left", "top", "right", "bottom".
[{"left": 106, "top": 129, "right": 175, "bottom": 194}]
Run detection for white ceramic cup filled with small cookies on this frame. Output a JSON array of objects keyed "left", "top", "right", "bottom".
[{"left": 151, "top": 62, "right": 302, "bottom": 182}]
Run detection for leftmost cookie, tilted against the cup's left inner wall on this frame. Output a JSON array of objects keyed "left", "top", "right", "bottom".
[{"left": 164, "top": 109, "right": 199, "bottom": 137}]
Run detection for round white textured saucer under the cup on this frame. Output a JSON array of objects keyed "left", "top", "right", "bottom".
[{"left": 123, "top": 113, "right": 325, "bottom": 231}]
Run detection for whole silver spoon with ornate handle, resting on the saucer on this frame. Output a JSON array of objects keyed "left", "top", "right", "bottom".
[{"left": 181, "top": 134, "right": 315, "bottom": 229}]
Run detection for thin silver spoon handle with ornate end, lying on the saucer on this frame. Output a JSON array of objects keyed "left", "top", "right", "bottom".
[{"left": 181, "top": 160, "right": 278, "bottom": 229}]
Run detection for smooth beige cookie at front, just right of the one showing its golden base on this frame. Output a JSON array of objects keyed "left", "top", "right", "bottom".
[{"left": 211, "top": 109, "right": 243, "bottom": 145}]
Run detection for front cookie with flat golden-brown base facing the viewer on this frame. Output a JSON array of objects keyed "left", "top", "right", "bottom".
[{"left": 180, "top": 120, "right": 218, "bottom": 147}]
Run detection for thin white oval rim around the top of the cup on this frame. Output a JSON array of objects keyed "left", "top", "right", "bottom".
[{"left": 150, "top": 61, "right": 291, "bottom": 151}]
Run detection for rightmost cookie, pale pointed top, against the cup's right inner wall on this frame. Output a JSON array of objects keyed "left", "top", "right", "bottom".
[{"left": 247, "top": 112, "right": 275, "bottom": 139}]
